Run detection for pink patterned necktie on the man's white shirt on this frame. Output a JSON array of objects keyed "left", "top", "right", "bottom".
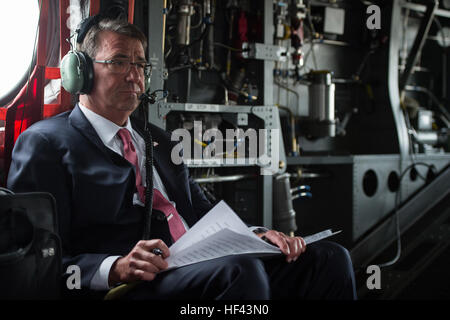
[{"left": 117, "top": 128, "right": 186, "bottom": 242}]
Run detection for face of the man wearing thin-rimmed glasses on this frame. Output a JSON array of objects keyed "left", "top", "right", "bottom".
[{"left": 83, "top": 31, "right": 145, "bottom": 125}]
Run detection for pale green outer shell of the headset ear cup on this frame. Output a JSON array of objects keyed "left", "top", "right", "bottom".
[{"left": 60, "top": 51, "right": 84, "bottom": 94}]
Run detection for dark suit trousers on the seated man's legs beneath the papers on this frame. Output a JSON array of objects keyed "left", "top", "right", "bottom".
[{"left": 123, "top": 240, "right": 356, "bottom": 300}]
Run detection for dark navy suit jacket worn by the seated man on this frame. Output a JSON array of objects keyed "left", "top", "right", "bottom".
[{"left": 8, "top": 106, "right": 212, "bottom": 288}]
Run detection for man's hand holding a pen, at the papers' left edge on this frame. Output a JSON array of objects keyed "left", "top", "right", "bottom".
[{"left": 108, "top": 239, "right": 170, "bottom": 286}]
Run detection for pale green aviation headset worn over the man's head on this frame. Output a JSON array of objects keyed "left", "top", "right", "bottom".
[{"left": 60, "top": 14, "right": 150, "bottom": 94}]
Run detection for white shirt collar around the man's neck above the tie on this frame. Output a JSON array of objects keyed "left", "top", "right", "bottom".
[{"left": 78, "top": 102, "right": 135, "bottom": 145}]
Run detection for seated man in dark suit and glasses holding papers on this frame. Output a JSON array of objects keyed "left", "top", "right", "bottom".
[{"left": 8, "top": 16, "right": 356, "bottom": 299}]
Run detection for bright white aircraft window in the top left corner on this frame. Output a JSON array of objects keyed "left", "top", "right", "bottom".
[{"left": 0, "top": 0, "right": 39, "bottom": 101}]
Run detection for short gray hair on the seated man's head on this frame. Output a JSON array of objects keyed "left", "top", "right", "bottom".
[{"left": 78, "top": 19, "right": 147, "bottom": 59}]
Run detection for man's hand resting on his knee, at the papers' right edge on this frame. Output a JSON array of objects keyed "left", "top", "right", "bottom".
[{"left": 258, "top": 230, "right": 306, "bottom": 262}]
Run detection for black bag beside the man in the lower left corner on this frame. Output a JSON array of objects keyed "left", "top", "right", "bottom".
[{"left": 0, "top": 188, "right": 62, "bottom": 300}]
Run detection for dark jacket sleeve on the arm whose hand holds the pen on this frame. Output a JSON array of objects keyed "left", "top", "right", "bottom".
[{"left": 7, "top": 128, "right": 108, "bottom": 289}]
